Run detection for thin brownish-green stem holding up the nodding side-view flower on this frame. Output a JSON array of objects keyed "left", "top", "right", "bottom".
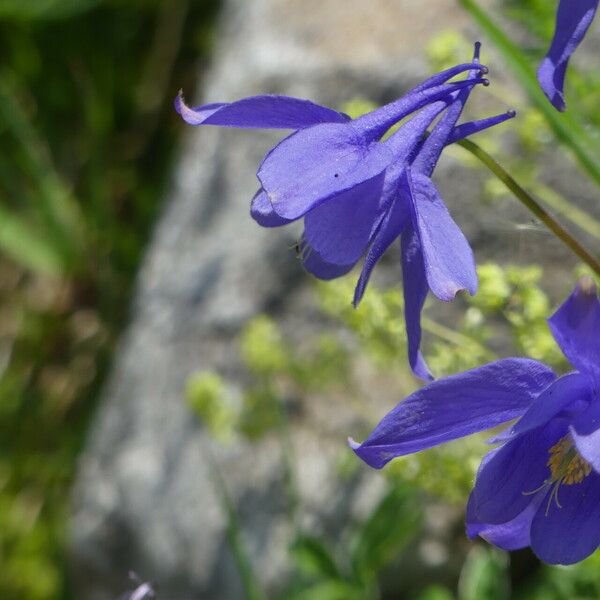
[{"left": 457, "top": 140, "right": 600, "bottom": 275}]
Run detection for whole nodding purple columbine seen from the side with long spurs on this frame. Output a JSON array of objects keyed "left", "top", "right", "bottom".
[{"left": 175, "top": 44, "right": 514, "bottom": 379}]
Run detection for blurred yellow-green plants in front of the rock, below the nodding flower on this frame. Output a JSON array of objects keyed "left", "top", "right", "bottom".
[{"left": 187, "top": 263, "right": 600, "bottom": 600}]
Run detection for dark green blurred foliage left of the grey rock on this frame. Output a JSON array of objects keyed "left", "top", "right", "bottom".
[{"left": 0, "top": 0, "right": 218, "bottom": 600}]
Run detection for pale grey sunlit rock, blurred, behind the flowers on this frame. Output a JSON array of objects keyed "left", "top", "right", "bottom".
[{"left": 72, "top": 0, "right": 596, "bottom": 600}]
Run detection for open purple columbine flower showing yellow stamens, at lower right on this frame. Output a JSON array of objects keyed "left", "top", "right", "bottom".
[{"left": 350, "top": 278, "right": 600, "bottom": 564}]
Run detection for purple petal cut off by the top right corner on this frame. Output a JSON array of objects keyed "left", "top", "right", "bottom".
[{"left": 537, "top": 0, "right": 598, "bottom": 111}]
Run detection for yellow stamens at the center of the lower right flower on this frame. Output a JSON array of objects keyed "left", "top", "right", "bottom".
[{"left": 523, "top": 434, "right": 592, "bottom": 516}]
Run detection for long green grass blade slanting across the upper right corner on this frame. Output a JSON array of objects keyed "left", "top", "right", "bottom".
[{"left": 460, "top": 0, "right": 600, "bottom": 186}]
